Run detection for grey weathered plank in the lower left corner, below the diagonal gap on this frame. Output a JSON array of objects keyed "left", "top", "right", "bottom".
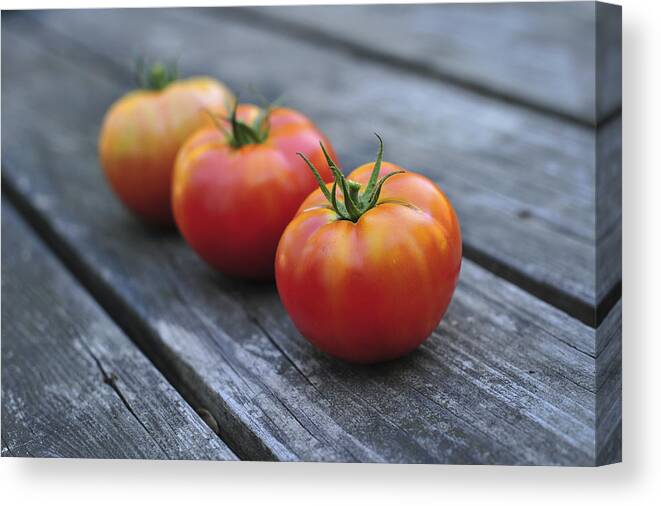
[{"left": 2, "top": 198, "right": 236, "bottom": 460}]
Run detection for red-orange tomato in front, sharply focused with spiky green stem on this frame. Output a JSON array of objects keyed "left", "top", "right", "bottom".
[{"left": 275, "top": 139, "right": 461, "bottom": 363}]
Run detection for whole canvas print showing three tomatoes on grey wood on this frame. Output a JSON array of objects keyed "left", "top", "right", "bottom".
[{"left": 1, "top": 2, "right": 622, "bottom": 466}]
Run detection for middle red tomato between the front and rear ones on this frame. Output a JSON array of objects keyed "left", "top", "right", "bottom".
[{"left": 172, "top": 104, "right": 332, "bottom": 278}]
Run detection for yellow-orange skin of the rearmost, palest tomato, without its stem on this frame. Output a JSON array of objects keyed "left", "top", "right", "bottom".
[{"left": 99, "top": 77, "right": 234, "bottom": 224}]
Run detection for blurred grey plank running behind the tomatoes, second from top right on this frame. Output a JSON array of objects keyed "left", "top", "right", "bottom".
[{"left": 19, "top": 9, "right": 615, "bottom": 325}]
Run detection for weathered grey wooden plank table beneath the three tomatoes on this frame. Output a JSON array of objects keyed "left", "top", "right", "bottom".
[{"left": 2, "top": 2, "right": 621, "bottom": 465}]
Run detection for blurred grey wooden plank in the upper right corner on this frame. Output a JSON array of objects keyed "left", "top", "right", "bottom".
[{"left": 232, "top": 2, "right": 622, "bottom": 125}]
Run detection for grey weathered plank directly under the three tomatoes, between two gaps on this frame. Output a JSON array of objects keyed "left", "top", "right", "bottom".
[{"left": 2, "top": 18, "right": 596, "bottom": 465}]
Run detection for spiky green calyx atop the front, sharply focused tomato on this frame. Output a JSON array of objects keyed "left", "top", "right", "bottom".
[{"left": 297, "top": 134, "right": 404, "bottom": 223}]
